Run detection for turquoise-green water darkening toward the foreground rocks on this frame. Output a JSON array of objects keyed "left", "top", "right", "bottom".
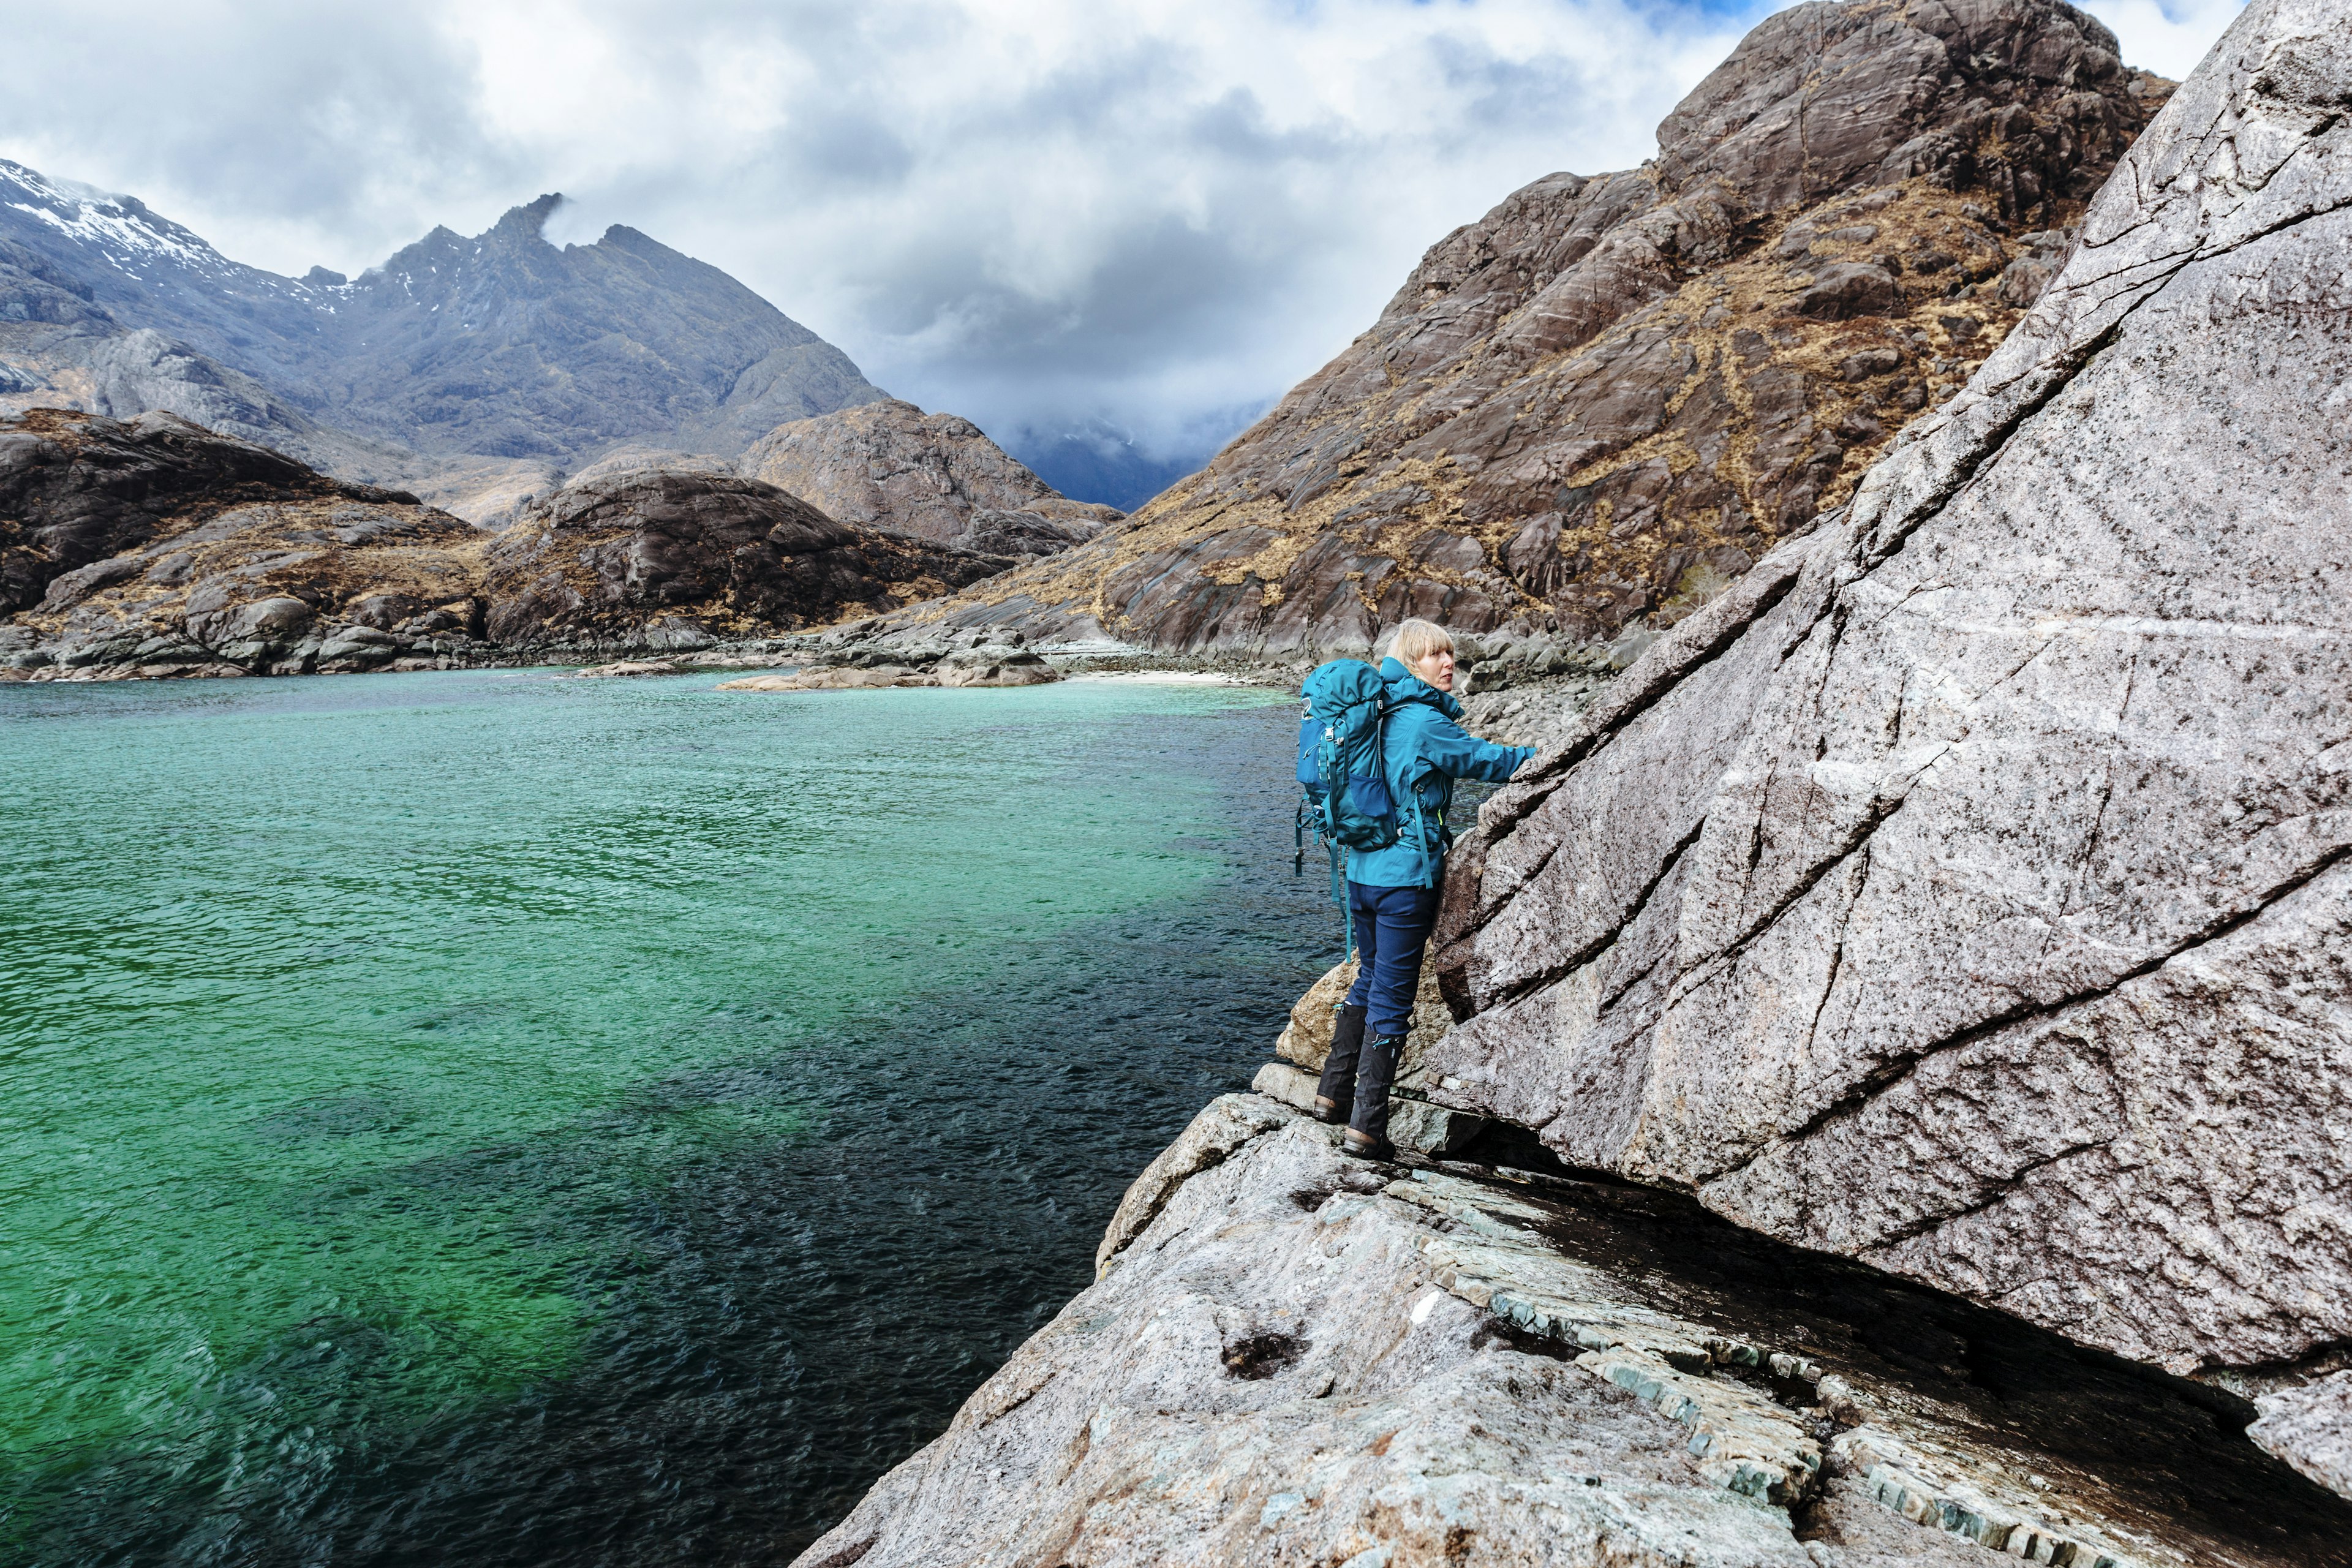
[{"left": 0, "top": 673, "right": 1336, "bottom": 1563}]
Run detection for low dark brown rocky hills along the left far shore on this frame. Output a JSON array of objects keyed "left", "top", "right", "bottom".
[{"left": 0, "top": 412, "right": 1011, "bottom": 679}]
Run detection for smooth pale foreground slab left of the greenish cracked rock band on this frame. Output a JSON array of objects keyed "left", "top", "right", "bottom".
[{"left": 800, "top": 1102, "right": 1811, "bottom": 1568}]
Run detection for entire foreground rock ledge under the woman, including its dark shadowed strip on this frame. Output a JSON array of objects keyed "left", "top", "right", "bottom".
[{"left": 800, "top": 1096, "right": 2352, "bottom": 1568}]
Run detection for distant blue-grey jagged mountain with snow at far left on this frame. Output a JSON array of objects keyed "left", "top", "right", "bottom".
[{"left": 0, "top": 160, "right": 882, "bottom": 477}]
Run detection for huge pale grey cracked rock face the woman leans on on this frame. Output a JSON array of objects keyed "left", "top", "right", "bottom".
[{"left": 1430, "top": 0, "right": 2352, "bottom": 1474}]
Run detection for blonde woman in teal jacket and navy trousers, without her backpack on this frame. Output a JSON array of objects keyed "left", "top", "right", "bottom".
[{"left": 1315, "top": 620, "right": 1536, "bottom": 1159}]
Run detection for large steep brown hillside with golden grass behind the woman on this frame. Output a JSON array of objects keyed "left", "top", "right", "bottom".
[{"left": 894, "top": 0, "right": 2171, "bottom": 649}]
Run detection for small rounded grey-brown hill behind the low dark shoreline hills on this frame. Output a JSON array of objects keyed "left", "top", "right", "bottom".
[{"left": 739, "top": 398, "right": 1125, "bottom": 557}]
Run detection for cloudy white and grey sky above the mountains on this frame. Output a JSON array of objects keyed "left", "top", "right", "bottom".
[{"left": 0, "top": 0, "right": 2242, "bottom": 479}]
